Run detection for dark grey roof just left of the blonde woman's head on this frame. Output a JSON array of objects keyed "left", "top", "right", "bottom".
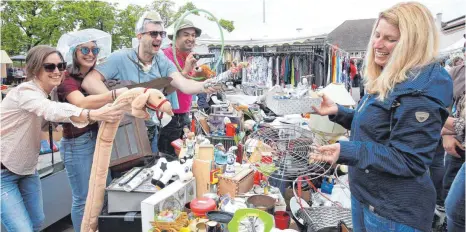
[{"left": 327, "top": 19, "right": 377, "bottom": 52}]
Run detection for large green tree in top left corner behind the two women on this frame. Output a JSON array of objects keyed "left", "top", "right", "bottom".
[{"left": 1, "top": 0, "right": 117, "bottom": 54}]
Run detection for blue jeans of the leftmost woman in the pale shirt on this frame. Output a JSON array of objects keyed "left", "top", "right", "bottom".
[{"left": 1, "top": 169, "right": 45, "bottom": 232}]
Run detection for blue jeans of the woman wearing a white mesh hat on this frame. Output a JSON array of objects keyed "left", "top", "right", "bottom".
[{"left": 60, "top": 131, "right": 111, "bottom": 232}]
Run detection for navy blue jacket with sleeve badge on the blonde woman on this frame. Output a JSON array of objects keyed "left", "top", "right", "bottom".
[{"left": 329, "top": 63, "right": 453, "bottom": 231}]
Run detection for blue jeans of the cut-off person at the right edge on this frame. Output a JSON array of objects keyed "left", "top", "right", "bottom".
[{"left": 445, "top": 163, "right": 465, "bottom": 232}]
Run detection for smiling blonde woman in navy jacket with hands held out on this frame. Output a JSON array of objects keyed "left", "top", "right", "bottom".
[{"left": 312, "top": 2, "right": 453, "bottom": 231}]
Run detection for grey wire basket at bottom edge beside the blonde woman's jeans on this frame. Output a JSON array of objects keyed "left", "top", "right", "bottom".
[{"left": 298, "top": 206, "right": 353, "bottom": 232}]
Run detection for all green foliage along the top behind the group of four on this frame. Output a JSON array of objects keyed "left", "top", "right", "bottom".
[{"left": 0, "top": 0, "right": 235, "bottom": 55}]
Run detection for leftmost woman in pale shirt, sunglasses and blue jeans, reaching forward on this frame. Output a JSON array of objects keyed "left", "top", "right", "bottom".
[{"left": 0, "top": 45, "right": 123, "bottom": 232}]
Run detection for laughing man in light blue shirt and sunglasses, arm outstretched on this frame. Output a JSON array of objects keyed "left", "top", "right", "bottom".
[{"left": 83, "top": 12, "right": 216, "bottom": 155}]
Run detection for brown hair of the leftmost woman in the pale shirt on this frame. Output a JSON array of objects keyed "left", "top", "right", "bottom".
[{"left": 26, "top": 45, "right": 64, "bottom": 80}]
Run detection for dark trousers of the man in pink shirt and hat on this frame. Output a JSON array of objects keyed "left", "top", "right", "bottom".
[{"left": 158, "top": 113, "right": 190, "bottom": 157}]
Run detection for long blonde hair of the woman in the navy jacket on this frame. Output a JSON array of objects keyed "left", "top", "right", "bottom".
[{"left": 364, "top": 2, "right": 439, "bottom": 100}]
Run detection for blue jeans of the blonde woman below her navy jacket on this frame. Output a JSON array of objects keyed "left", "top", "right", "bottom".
[{"left": 351, "top": 196, "right": 420, "bottom": 232}]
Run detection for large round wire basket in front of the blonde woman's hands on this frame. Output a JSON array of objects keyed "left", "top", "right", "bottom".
[{"left": 243, "top": 124, "right": 331, "bottom": 182}]
